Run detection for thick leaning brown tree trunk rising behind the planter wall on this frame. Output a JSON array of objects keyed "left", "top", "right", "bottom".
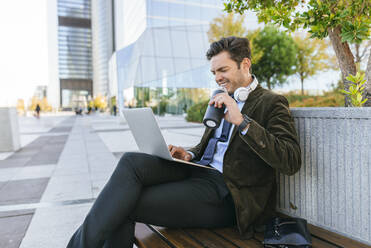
[{"left": 328, "top": 27, "right": 357, "bottom": 107}]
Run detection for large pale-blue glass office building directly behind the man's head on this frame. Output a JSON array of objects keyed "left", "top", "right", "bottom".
[{"left": 112, "top": 0, "right": 223, "bottom": 114}]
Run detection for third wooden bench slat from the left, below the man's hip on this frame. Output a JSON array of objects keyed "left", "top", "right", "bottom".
[{"left": 183, "top": 229, "right": 238, "bottom": 248}]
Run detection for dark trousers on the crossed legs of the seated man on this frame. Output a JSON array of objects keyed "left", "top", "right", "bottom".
[{"left": 67, "top": 153, "right": 235, "bottom": 248}]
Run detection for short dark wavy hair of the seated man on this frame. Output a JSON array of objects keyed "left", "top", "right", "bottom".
[{"left": 206, "top": 36, "right": 251, "bottom": 68}]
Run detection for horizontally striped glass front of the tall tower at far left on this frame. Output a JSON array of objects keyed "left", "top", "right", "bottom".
[{"left": 58, "top": 0, "right": 93, "bottom": 109}]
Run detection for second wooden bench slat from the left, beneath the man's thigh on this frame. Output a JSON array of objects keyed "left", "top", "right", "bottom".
[{"left": 151, "top": 226, "right": 203, "bottom": 248}]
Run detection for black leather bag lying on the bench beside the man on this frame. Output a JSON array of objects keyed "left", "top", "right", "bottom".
[{"left": 263, "top": 217, "right": 312, "bottom": 248}]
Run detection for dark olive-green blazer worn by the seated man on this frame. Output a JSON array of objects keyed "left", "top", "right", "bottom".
[{"left": 190, "top": 85, "right": 301, "bottom": 238}]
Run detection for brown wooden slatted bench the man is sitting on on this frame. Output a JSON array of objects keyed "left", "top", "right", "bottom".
[{"left": 135, "top": 220, "right": 371, "bottom": 248}]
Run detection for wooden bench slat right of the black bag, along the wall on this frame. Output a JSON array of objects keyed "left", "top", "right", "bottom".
[{"left": 308, "top": 224, "right": 371, "bottom": 248}]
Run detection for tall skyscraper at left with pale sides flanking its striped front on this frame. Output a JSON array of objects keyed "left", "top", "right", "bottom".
[{"left": 47, "top": 0, "right": 113, "bottom": 109}]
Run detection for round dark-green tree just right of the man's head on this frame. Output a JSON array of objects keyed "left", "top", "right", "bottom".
[{"left": 252, "top": 26, "right": 296, "bottom": 89}]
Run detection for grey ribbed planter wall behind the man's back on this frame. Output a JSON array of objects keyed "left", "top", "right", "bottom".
[{"left": 277, "top": 108, "right": 371, "bottom": 244}]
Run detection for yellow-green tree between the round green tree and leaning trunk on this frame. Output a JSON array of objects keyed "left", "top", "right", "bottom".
[{"left": 294, "top": 34, "right": 335, "bottom": 95}]
